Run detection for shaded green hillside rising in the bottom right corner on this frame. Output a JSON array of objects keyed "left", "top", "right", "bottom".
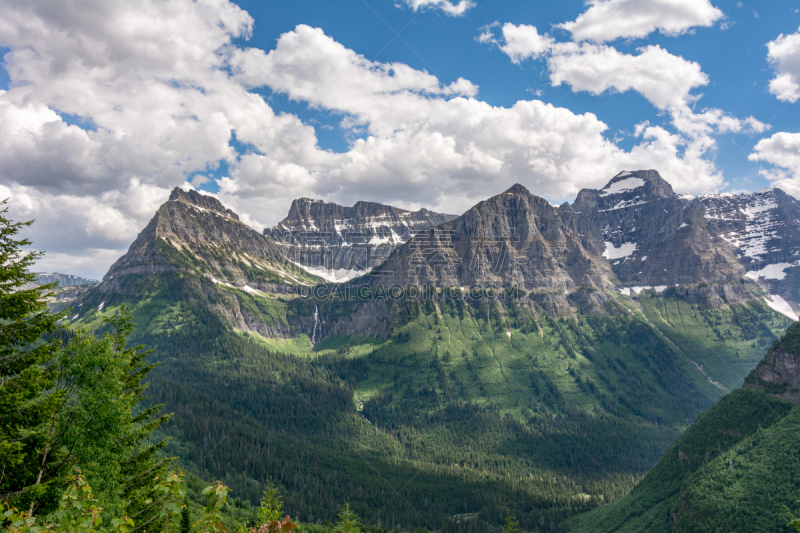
[{"left": 571, "top": 323, "right": 800, "bottom": 532}]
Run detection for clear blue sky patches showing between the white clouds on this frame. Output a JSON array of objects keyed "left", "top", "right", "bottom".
[{"left": 223, "top": 0, "right": 800, "bottom": 191}]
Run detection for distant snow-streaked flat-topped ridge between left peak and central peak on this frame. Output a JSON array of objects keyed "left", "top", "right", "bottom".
[{"left": 264, "top": 198, "right": 455, "bottom": 274}]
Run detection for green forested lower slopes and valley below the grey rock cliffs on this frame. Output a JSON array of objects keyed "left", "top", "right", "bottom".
[{"left": 62, "top": 273, "right": 786, "bottom": 531}]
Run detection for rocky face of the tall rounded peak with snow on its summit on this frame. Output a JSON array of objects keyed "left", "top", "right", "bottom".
[{"left": 561, "top": 170, "right": 744, "bottom": 286}]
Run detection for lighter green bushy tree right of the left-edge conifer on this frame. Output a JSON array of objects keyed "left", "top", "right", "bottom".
[{"left": 57, "top": 306, "right": 171, "bottom": 530}]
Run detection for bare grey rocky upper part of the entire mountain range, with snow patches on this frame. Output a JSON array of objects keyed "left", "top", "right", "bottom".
[{"left": 78, "top": 170, "right": 800, "bottom": 318}]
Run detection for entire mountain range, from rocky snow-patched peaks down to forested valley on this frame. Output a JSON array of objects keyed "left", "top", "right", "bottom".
[{"left": 56, "top": 170, "right": 800, "bottom": 532}]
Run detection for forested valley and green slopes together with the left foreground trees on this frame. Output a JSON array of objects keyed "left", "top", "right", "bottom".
[{"left": 0, "top": 202, "right": 800, "bottom": 533}]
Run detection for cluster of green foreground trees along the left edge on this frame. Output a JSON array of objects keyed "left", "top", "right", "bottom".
[{"left": 0, "top": 210, "right": 169, "bottom": 529}]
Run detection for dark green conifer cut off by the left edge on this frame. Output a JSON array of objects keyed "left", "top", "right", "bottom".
[{"left": 0, "top": 201, "right": 65, "bottom": 512}]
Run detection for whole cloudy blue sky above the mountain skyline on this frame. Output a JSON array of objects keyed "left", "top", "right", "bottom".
[{"left": 0, "top": 0, "right": 800, "bottom": 277}]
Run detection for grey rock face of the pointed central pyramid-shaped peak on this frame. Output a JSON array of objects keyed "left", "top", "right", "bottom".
[{"left": 369, "top": 185, "right": 612, "bottom": 291}]
